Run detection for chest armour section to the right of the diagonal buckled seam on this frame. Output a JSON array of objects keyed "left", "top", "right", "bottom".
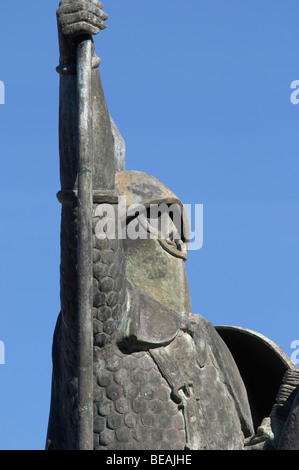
[{"left": 152, "top": 331, "right": 244, "bottom": 450}]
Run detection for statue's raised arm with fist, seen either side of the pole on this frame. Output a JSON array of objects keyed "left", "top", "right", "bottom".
[{"left": 57, "top": 0, "right": 114, "bottom": 189}]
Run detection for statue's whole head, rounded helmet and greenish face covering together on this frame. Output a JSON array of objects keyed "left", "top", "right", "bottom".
[{"left": 115, "top": 171, "right": 191, "bottom": 315}]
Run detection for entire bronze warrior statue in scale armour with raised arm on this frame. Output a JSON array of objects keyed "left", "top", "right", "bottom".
[{"left": 46, "top": 0, "right": 299, "bottom": 451}]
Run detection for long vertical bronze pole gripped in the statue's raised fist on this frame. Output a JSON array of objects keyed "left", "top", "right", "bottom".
[{"left": 77, "top": 37, "right": 93, "bottom": 450}]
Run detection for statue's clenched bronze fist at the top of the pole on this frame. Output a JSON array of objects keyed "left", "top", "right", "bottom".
[{"left": 57, "top": 0, "right": 108, "bottom": 37}]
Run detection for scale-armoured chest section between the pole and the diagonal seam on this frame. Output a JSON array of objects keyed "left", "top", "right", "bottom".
[{"left": 94, "top": 349, "right": 186, "bottom": 450}]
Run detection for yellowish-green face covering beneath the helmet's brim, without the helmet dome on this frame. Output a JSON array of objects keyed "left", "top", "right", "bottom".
[{"left": 124, "top": 208, "right": 191, "bottom": 315}]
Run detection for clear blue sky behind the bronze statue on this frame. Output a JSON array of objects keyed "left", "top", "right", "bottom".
[{"left": 0, "top": 0, "right": 299, "bottom": 449}]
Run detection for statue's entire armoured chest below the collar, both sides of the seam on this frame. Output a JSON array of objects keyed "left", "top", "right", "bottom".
[{"left": 94, "top": 332, "right": 243, "bottom": 450}]
